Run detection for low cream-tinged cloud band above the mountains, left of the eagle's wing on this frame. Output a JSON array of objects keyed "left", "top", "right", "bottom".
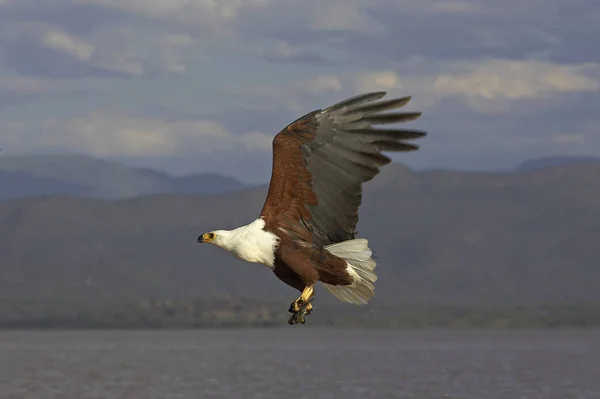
[{"left": 0, "top": 111, "right": 272, "bottom": 157}]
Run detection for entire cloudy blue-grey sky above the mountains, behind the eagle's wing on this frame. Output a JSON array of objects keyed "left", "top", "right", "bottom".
[{"left": 0, "top": 0, "right": 600, "bottom": 182}]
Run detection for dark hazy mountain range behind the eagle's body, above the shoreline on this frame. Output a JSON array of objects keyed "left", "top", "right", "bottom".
[{"left": 0, "top": 159, "right": 600, "bottom": 324}]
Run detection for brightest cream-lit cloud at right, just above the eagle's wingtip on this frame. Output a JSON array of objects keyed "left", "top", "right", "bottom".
[{"left": 341, "top": 58, "right": 600, "bottom": 114}]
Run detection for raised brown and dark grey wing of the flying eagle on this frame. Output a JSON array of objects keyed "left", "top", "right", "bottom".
[{"left": 261, "top": 92, "right": 426, "bottom": 247}]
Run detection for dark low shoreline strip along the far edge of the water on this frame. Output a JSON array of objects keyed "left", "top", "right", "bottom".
[{"left": 0, "top": 299, "right": 600, "bottom": 330}]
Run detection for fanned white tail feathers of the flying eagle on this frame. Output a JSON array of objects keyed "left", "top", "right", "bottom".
[{"left": 323, "top": 238, "right": 377, "bottom": 305}]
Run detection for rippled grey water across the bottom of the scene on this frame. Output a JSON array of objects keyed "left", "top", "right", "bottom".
[{"left": 0, "top": 326, "right": 600, "bottom": 399}]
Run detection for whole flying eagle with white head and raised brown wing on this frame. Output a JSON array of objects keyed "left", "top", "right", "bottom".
[{"left": 197, "top": 91, "right": 427, "bottom": 325}]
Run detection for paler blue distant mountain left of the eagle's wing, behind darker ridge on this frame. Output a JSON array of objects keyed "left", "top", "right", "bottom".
[{"left": 0, "top": 154, "right": 245, "bottom": 200}]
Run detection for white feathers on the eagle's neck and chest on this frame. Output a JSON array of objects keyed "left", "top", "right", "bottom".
[{"left": 212, "top": 219, "right": 279, "bottom": 268}]
